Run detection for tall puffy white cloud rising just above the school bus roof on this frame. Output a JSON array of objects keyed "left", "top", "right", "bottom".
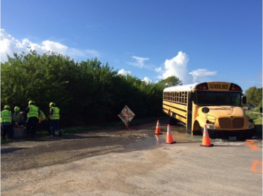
[{"left": 159, "top": 51, "right": 217, "bottom": 84}]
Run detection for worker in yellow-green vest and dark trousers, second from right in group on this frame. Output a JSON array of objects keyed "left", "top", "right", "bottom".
[{"left": 20, "top": 101, "right": 40, "bottom": 138}]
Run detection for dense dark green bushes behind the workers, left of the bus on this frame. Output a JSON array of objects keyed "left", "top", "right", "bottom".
[{"left": 1, "top": 51, "right": 170, "bottom": 126}]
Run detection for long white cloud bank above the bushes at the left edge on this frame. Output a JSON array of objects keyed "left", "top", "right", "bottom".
[{"left": 0, "top": 29, "right": 100, "bottom": 62}]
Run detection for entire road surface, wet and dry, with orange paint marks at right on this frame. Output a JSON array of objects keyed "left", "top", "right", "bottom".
[{"left": 1, "top": 122, "right": 262, "bottom": 196}]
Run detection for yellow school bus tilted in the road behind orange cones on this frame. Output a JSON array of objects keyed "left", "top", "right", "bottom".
[{"left": 163, "top": 82, "right": 256, "bottom": 139}]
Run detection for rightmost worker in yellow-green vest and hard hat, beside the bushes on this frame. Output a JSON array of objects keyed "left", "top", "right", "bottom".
[{"left": 48, "top": 102, "right": 62, "bottom": 137}]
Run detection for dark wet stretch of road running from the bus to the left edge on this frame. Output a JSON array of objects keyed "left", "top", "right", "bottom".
[{"left": 1, "top": 119, "right": 260, "bottom": 173}]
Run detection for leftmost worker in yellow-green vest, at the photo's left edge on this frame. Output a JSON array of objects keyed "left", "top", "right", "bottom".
[{"left": 0, "top": 105, "right": 14, "bottom": 139}]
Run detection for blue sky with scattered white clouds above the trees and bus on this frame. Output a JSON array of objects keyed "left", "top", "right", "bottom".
[{"left": 0, "top": 0, "right": 262, "bottom": 91}]
